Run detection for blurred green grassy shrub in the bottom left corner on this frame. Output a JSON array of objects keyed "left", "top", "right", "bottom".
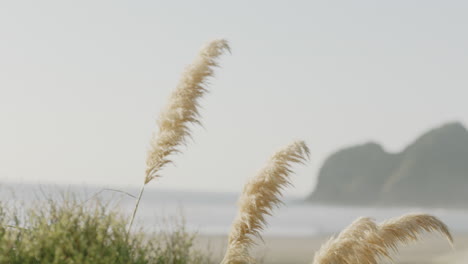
[{"left": 0, "top": 199, "right": 211, "bottom": 264}]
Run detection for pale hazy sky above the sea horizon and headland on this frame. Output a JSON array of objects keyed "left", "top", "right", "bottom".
[{"left": 0, "top": 0, "right": 468, "bottom": 195}]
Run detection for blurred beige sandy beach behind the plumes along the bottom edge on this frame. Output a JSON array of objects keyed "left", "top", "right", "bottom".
[{"left": 196, "top": 234, "right": 468, "bottom": 264}]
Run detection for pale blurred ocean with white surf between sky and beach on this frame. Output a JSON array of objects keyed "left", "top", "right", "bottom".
[{"left": 0, "top": 184, "right": 468, "bottom": 237}]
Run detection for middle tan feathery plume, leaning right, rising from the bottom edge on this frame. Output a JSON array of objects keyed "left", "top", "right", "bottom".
[{"left": 221, "top": 141, "right": 309, "bottom": 264}]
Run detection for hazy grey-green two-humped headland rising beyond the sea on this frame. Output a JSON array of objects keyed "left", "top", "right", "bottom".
[{"left": 307, "top": 123, "right": 468, "bottom": 207}]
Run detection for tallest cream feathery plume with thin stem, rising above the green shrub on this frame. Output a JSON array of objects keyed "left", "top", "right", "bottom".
[{"left": 128, "top": 39, "right": 230, "bottom": 232}]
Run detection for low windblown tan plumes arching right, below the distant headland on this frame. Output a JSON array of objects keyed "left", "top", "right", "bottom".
[{"left": 313, "top": 214, "right": 453, "bottom": 264}]
